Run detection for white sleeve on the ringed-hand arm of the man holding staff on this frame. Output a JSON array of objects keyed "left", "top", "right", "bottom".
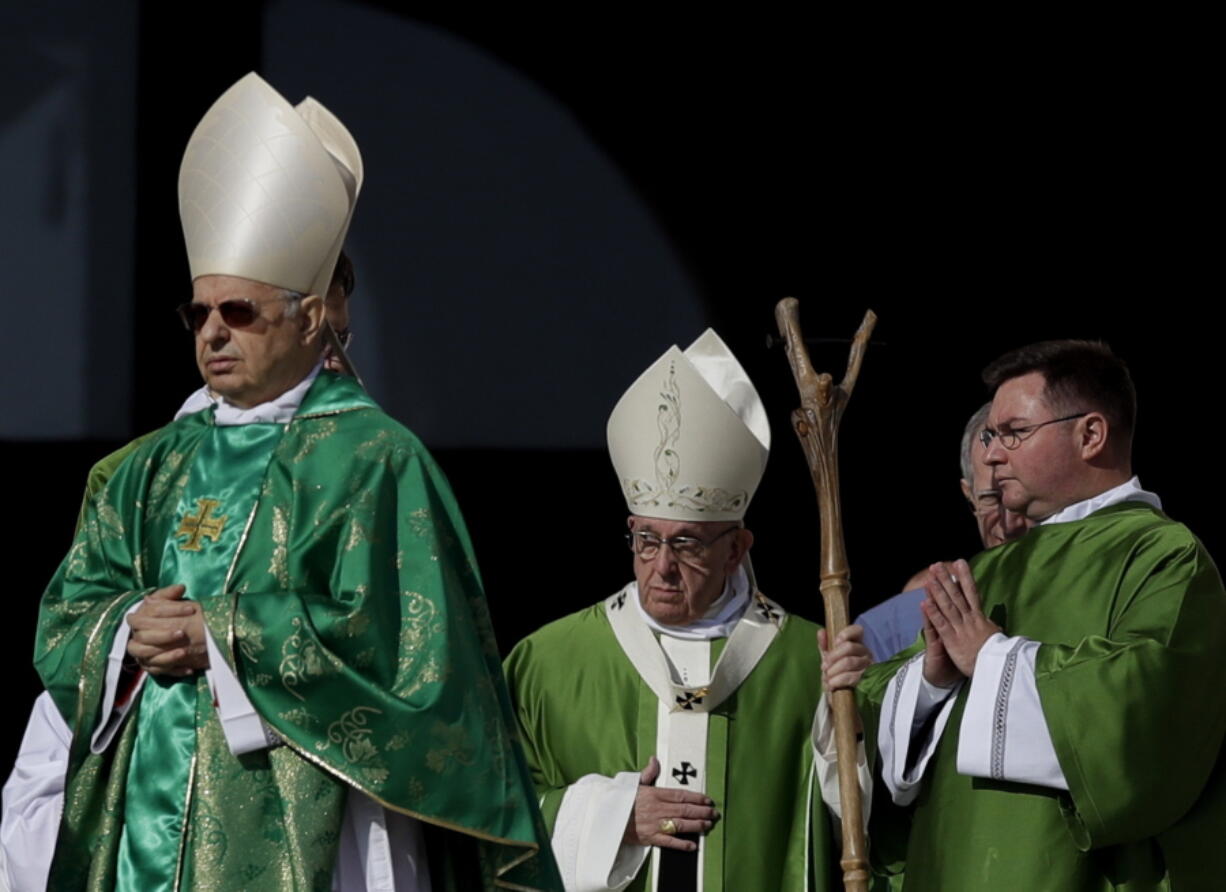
[{"left": 553, "top": 771, "right": 650, "bottom": 892}]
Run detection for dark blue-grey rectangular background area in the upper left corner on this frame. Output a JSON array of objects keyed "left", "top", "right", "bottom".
[{"left": 0, "top": 0, "right": 136, "bottom": 440}]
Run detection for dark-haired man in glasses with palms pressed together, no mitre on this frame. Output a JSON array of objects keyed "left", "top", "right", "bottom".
[{"left": 861, "top": 341, "right": 1226, "bottom": 892}]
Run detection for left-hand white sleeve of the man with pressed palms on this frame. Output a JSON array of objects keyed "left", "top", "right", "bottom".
[{"left": 877, "top": 651, "right": 961, "bottom": 805}]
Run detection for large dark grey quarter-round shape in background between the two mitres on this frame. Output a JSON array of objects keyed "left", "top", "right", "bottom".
[{"left": 262, "top": 0, "right": 705, "bottom": 448}]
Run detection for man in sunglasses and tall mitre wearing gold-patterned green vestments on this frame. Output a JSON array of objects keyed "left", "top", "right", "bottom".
[{"left": 25, "top": 75, "right": 559, "bottom": 892}]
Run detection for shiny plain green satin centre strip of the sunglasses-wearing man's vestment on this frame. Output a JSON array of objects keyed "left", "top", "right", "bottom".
[{"left": 116, "top": 424, "right": 284, "bottom": 892}]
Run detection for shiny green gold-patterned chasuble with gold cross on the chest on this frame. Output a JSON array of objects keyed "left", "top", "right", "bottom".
[{"left": 36, "top": 372, "right": 560, "bottom": 892}]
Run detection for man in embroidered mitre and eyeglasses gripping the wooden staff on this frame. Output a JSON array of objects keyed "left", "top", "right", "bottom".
[{"left": 505, "top": 331, "right": 869, "bottom": 892}]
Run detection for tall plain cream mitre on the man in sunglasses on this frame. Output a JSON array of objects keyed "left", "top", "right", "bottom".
[{"left": 179, "top": 72, "right": 362, "bottom": 297}]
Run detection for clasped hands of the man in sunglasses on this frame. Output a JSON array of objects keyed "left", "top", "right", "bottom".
[{"left": 128, "top": 586, "right": 208, "bottom": 678}]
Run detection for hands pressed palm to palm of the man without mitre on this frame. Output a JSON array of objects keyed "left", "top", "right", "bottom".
[{"left": 920, "top": 560, "right": 1000, "bottom": 687}]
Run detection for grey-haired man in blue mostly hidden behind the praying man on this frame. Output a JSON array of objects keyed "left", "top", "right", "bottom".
[{"left": 856, "top": 403, "right": 1034, "bottom": 662}]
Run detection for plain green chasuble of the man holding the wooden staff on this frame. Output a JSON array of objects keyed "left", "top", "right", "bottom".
[{"left": 504, "top": 592, "right": 837, "bottom": 892}]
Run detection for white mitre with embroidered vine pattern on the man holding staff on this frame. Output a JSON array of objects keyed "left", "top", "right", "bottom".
[{"left": 608, "top": 328, "right": 770, "bottom": 521}]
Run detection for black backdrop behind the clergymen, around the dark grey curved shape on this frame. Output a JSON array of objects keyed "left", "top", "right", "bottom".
[{"left": 4, "top": 2, "right": 1224, "bottom": 763}]
